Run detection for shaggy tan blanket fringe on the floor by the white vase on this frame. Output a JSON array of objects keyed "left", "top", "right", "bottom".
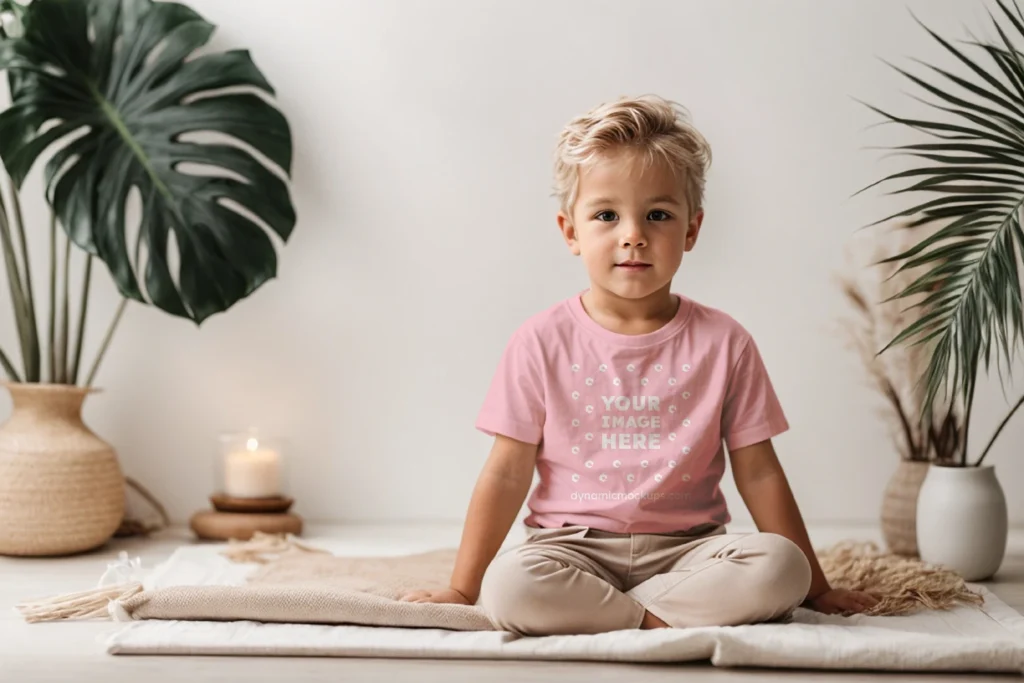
[{"left": 817, "top": 541, "right": 984, "bottom": 616}]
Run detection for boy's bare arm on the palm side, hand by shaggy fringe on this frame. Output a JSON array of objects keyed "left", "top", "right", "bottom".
[{"left": 729, "top": 439, "right": 878, "bottom": 613}]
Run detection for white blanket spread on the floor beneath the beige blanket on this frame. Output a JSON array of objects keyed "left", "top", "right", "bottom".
[{"left": 106, "top": 542, "right": 1024, "bottom": 673}]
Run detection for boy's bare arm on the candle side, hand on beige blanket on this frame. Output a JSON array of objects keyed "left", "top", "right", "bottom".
[{"left": 401, "top": 434, "right": 537, "bottom": 604}]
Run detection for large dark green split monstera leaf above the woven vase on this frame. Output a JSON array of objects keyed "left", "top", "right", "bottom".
[{"left": 0, "top": 0, "right": 295, "bottom": 324}]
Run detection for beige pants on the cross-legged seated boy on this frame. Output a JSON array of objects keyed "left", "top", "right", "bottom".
[{"left": 479, "top": 525, "right": 811, "bottom": 636}]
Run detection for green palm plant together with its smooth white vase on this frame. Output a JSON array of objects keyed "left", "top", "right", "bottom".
[{"left": 861, "top": 0, "right": 1024, "bottom": 580}]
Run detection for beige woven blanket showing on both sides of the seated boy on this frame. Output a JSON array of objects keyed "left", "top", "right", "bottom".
[{"left": 96, "top": 536, "right": 981, "bottom": 631}]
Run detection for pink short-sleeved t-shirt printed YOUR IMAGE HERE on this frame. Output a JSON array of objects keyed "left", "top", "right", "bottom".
[{"left": 476, "top": 288, "right": 788, "bottom": 533}]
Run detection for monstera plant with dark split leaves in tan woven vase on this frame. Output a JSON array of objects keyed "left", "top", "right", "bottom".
[{"left": 0, "top": 0, "right": 295, "bottom": 555}]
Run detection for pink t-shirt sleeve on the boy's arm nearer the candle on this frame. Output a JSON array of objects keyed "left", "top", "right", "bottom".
[{"left": 476, "top": 332, "right": 546, "bottom": 443}]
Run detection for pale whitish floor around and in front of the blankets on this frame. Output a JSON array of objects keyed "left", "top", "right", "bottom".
[{"left": 0, "top": 525, "right": 1024, "bottom": 683}]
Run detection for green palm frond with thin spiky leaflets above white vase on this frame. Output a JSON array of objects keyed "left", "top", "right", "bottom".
[{"left": 861, "top": 0, "right": 1024, "bottom": 421}]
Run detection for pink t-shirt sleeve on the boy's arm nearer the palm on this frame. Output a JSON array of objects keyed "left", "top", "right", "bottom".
[{"left": 722, "top": 338, "right": 790, "bottom": 451}]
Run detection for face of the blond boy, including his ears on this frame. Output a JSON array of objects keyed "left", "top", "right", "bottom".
[{"left": 558, "top": 152, "right": 703, "bottom": 299}]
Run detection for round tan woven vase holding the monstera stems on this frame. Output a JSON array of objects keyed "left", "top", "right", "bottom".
[{"left": 0, "top": 384, "right": 125, "bottom": 555}]
